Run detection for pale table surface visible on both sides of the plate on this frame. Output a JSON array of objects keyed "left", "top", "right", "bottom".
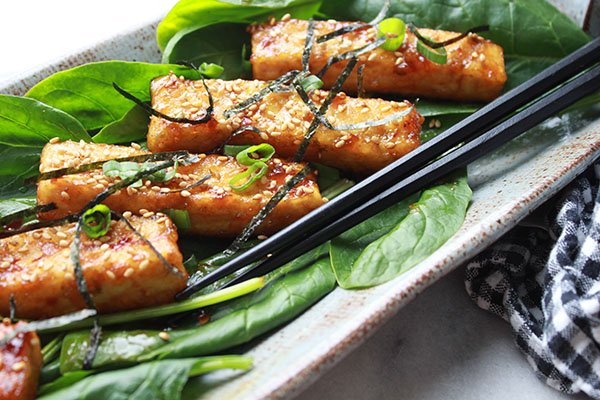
[{"left": 0, "top": 0, "right": 586, "bottom": 400}]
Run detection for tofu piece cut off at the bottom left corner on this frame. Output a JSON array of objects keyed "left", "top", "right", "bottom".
[{"left": 0, "top": 319, "right": 42, "bottom": 400}]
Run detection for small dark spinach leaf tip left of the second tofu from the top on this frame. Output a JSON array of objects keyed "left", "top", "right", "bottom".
[{"left": 92, "top": 105, "right": 150, "bottom": 144}]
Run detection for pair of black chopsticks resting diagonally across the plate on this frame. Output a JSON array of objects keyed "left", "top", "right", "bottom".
[{"left": 177, "top": 38, "right": 600, "bottom": 299}]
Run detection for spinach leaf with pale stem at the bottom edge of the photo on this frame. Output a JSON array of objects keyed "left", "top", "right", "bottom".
[{"left": 40, "top": 356, "right": 252, "bottom": 400}]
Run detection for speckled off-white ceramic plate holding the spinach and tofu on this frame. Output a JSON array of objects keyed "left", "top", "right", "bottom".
[{"left": 0, "top": 8, "right": 600, "bottom": 399}]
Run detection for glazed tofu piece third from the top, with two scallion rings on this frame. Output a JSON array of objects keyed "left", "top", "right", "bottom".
[{"left": 37, "top": 142, "right": 324, "bottom": 237}]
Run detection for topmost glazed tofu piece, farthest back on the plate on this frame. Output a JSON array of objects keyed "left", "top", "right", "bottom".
[{"left": 249, "top": 20, "right": 506, "bottom": 101}]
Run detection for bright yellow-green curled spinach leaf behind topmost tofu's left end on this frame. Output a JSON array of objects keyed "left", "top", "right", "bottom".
[{"left": 157, "top": 0, "right": 321, "bottom": 79}]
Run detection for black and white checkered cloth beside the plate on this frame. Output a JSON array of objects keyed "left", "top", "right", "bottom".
[{"left": 465, "top": 161, "right": 600, "bottom": 399}]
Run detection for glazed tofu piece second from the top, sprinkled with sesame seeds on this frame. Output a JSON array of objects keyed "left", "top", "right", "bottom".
[{"left": 148, "top": 75, "right": 423, "bottom": 175}]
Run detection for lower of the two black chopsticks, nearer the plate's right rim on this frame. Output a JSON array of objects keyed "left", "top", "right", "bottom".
[{"left": 220, "top": 65, "right": 600, "bottom": 286}]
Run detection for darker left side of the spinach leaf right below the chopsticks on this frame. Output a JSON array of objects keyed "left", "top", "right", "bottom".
[{"left": 329, "top": 194, "right": 419, "bottom": 289}]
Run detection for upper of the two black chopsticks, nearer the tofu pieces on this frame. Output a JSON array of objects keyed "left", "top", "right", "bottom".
[{"left": 178, "top": 39, "right": 600, "bottom": 298}]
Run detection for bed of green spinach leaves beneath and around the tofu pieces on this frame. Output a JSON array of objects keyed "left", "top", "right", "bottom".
[{"left": 0, "top": 0, "right": 589, "bottom": 399}]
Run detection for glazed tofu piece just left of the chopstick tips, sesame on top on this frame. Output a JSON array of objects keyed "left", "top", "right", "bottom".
[{"left": 0, "top": 215, "right": 188, "bottom": 319}]
